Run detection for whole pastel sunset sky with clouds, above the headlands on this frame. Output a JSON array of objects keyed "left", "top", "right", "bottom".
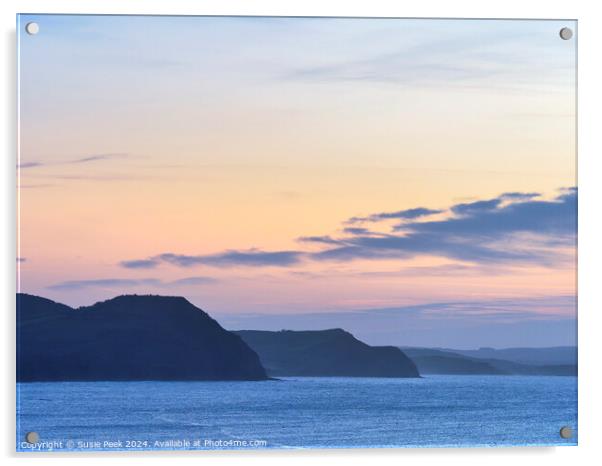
[{"left": 17, "top": 15, "right": 577, "bottom": 348}]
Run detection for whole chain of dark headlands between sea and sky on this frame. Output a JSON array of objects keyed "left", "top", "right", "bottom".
[{"left": 17, "top": 293, "right": 577, "bottom": 382}]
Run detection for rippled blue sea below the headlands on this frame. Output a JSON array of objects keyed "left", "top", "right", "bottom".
[{"left": 17, "top": 376, "right": 577, "bottom": 451}]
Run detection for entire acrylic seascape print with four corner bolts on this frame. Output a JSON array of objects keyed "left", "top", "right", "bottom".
[{"left": 16, "top": 15, "right": 577, "bottom": 451}]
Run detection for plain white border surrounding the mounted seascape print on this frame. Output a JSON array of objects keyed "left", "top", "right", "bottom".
[{"left": 0, "top": 0, "right": 602, "bottom": 466}]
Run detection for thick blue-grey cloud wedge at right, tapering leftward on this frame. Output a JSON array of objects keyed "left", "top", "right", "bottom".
[{"left": 312, "top": 189, "right": 577, "bottom": 266}]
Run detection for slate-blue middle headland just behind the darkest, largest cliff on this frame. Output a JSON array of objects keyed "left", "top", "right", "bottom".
[{"left": 235, "top": 329, "right": 420, "bottom": 377}]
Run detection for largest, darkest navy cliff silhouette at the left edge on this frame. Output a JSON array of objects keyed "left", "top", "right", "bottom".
[{"left": 17, "top": 294, "right": 267, "bottom": 382}]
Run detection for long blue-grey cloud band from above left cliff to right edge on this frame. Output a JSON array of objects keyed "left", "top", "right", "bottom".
[{"left": 120, "top": 188, "right": 577, "bottom": 269}]
